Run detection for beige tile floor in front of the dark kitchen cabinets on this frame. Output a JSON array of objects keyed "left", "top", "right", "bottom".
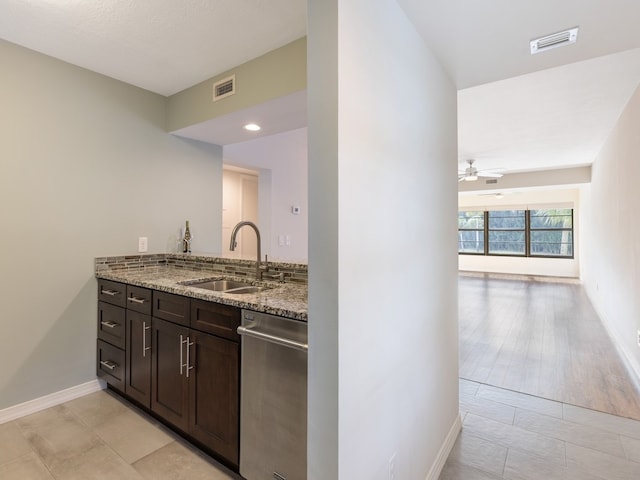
[{"left": 0, "top": 391, "right": 241, "bottom": 480}]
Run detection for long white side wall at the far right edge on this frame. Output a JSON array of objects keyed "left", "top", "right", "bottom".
[{"left": 581, "top": 83, "right": 640, "bottom": 378}]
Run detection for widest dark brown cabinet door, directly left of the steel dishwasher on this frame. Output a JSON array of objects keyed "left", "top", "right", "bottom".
[{"left": 189, "top": 330, "right": 240, "bottom": 468}]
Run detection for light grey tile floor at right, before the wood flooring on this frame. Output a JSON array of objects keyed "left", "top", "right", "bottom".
[{"left": 440, "top": 379, "right": 640, "bottom": 480}]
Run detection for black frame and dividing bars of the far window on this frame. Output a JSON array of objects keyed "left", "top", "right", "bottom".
[{"left": 458, "top": 206, "right": 575, "bottom": 260}]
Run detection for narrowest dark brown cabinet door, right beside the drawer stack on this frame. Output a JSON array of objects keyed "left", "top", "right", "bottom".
[{"left": 125, "top": 310, "right": 151, "bottom": 408}]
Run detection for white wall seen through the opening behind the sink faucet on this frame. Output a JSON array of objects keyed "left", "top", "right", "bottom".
[{"left": 224, "top": 128, "right": 309, "bottom": 263}]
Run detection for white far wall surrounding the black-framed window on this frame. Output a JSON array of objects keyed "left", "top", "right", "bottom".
[{"left": 458, "top": 188, "right": 581, "bottom": 278}]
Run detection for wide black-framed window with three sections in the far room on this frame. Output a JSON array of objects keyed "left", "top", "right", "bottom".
[{"left": 458, "top": 208, "right": 573, "bottom": 258}]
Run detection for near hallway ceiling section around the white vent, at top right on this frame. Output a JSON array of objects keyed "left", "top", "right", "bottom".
[{"left": 397, "top": 0, "right": 640, "bottom": 89}]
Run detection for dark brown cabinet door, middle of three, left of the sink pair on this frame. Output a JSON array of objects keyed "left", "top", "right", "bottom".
[{"left": 151, "top": 317, "right": 189, "bottom": 431}]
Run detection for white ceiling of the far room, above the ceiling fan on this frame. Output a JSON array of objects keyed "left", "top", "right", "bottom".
[{"left": 458, "top": 49, "right": 640, "bottom": 173}]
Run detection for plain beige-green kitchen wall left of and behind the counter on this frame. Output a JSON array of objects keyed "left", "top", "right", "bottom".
[{"left": 0, "top": 41, "right": 222, "bottom": 409}]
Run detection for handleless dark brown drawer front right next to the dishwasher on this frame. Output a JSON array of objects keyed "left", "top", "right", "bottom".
[{"left": 191, "top": 299, "right": 240, "bottom": 342}]
